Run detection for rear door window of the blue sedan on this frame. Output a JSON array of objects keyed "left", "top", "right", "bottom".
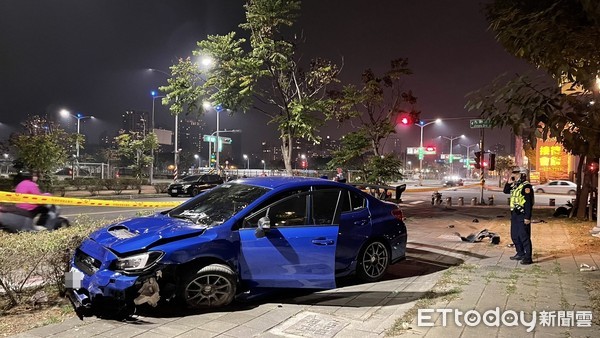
[{"left": 311, "top": 189, "right": 348, "bottom": 225}]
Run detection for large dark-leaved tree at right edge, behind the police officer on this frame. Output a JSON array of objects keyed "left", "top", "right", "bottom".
[{"left": 467, "top": 0, "right": 600, "bottom": 217}]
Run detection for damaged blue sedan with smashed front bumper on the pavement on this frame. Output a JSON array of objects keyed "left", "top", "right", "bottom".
[{"left": 65, "top": 177, "right": 407, "bottom": 317}]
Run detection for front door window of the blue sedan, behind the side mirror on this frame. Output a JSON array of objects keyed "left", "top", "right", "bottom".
[{"left": 244, "top": 192, "right": 309, "bottom": 228}]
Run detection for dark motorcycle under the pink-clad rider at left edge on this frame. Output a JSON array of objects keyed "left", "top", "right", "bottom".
[{"left": 0, "top": 204, "right": 71, "bottom": 232}]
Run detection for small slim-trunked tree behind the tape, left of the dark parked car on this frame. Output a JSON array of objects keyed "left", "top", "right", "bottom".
[{"left": 115, "top": 130, "right": 158, "bottom": 193}]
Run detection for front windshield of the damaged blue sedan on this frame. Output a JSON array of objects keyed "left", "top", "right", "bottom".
[{"left": 169, "top": 183, "right": 269, "bottom": 226}]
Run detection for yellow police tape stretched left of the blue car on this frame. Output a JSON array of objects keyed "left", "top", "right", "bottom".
[{"left": 0, "top": 191, "right": 181, "bottom": 208}]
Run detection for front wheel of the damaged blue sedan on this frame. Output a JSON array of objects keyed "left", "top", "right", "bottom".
[{"left": 181, "top": 264, "right": 236, "bottom": 309}]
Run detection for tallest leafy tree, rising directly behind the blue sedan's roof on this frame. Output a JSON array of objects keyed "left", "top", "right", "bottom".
[{"left": 160, "top": 0, "right": 339, "bottom": 174}]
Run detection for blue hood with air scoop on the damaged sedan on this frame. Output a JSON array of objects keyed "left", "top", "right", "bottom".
[{"left": 90, "top": 215, "right": 207, "bottom": 254}]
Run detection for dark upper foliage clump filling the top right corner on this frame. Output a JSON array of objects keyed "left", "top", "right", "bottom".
[{"left": 486, "top": 0, "right": 600, "bottom": 90}]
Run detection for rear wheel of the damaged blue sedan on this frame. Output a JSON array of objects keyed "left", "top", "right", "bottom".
[{"left": 356, "top": 241, "right": 390, "bottom": 282}]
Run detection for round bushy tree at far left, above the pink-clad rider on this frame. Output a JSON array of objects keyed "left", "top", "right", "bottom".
[{"left": 9, "top": 116, "right": 76, "bottom": 175}]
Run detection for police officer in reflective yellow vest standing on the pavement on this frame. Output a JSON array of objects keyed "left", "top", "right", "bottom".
[{"left": 504, "top": 168, "right": 534, "bottom": 265}]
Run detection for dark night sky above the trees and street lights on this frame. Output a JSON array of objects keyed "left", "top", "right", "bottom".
[{"left": 0, "top": 0, "right": 535, "bottom": 156}]
